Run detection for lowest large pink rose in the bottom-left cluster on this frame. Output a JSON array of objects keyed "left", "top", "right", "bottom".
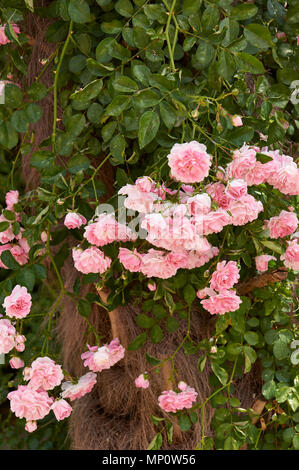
[{"left": 7, "top": 385, "right": 53, "bottom": 421}]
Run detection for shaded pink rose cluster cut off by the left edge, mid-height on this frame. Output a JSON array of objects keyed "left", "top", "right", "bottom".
[{"left": 0, "top": 190, "right": 30, "bottom": 269}]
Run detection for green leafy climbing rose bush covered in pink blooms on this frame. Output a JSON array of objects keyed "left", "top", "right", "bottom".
[{"left": 0, "top": 0, "right": 299, "bottom": 450}]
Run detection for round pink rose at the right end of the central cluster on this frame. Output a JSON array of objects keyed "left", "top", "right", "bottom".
[{"left": 228, "top": 194, "right": 264, "bottom": 225}]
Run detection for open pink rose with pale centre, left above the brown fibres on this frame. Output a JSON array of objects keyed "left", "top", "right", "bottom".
[{"left": 81, "top": 338, "right": 125, "bottom": 372}]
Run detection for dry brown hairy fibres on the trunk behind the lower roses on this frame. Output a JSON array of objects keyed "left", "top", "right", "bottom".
[{"left": 58, "top": 258, "right": 261, "bottom": 450}]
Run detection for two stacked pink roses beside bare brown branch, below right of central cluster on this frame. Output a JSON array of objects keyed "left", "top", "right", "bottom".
[{"left": 197, "top": 261, "right": 242, "bottom": 315}]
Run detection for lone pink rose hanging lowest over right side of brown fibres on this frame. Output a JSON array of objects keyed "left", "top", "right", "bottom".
[{"left": 158, "top": 382, "right": 197, "bottom": 413}]
